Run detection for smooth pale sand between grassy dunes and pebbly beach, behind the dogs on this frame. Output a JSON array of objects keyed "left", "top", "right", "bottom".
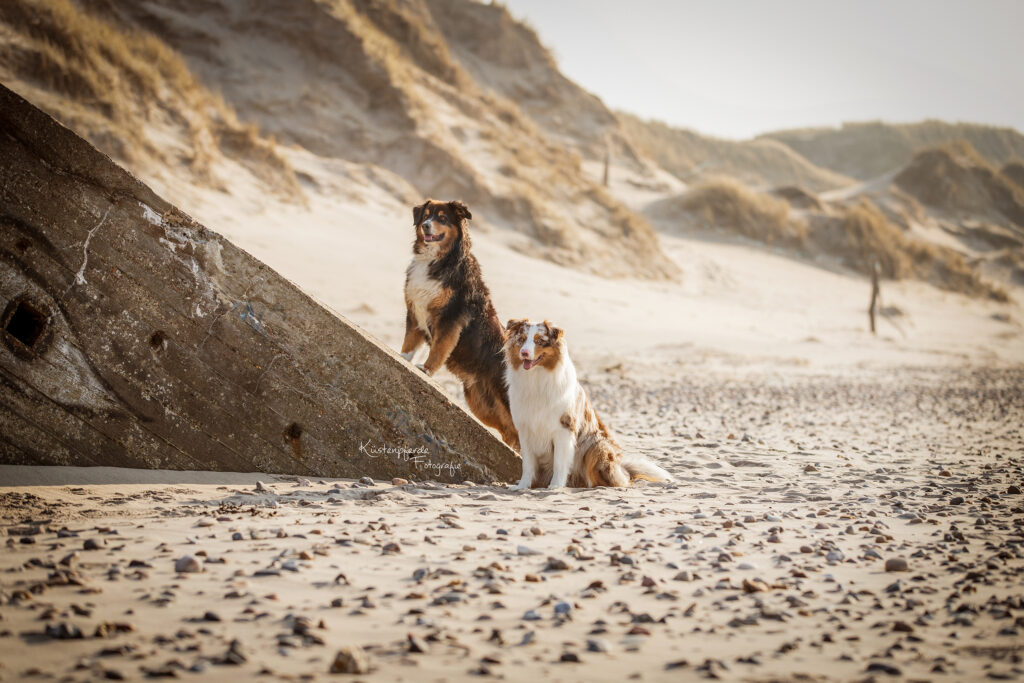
[{"left": 146, "top": 152, "right": 1024, "bottom": 378}]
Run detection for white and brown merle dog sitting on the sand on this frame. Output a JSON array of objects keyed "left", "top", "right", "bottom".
[{"left": 505, "top": 319, "right": 672, "bottom": 488}]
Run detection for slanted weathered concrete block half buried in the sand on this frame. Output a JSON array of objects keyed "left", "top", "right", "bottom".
[{"left": 0, "top": 86, "right": 519, "bottom": 481}]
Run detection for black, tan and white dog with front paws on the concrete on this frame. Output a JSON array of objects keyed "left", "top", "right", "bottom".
[{"left": 401, "top": 200, "right": 519, "bottom": 450}]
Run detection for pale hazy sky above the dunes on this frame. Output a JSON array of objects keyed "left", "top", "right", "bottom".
[{"left": 504, "top": 0, "right": 1024, "bottom": 138}]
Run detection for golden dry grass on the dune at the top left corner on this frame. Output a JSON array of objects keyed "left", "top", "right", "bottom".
[{"left": 0, "top": 0, "right": 301, "bottom": 198}]
